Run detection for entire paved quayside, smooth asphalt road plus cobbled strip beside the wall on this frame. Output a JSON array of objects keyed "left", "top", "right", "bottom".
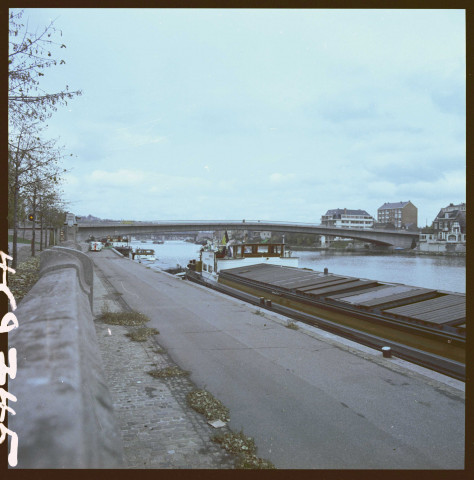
[{"left": 89, "top": 251, "right": 464, "bottom": 468}]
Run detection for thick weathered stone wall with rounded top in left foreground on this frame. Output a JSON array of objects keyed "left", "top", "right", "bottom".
[{"left": 9, "top": 244, "right": 122, "bottom": 468}]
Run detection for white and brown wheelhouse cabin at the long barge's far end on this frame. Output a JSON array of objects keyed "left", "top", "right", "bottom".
[{"left": 187, "top": 241, "right": 299, "bottom": 283}]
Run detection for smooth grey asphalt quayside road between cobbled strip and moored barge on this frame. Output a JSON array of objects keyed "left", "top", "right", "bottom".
[{"left": 90, "top": 250, "right": 465, "bottom": 469}]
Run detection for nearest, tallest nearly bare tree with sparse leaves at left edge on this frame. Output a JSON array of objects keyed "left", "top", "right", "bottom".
[{"left": 8, "top": 10, "right": 82, "bottom": 267}]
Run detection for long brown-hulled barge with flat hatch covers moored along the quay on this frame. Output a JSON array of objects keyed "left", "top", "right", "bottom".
[{"left": 187, "top": 242, "right": 466, "bottom": 379}]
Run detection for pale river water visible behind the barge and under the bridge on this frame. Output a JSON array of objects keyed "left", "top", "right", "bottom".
[{"left": 128, "top": 240, "right": 466, "bottom": 293}]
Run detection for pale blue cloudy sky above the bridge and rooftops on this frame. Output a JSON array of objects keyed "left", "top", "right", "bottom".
[{"left": 12, "top": 8, "right": 466, "bottom": 226}]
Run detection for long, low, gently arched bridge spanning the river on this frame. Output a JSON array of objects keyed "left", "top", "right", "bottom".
[{"left": 76, "top": 220, "right": 419, "bottom": 249}]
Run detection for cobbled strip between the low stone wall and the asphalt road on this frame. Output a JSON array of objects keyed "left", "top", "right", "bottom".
[{"left": 94, "top": 256, "right": 236, "bottom": 469}]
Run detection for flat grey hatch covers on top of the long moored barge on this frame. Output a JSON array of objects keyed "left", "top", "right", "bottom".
[{"left": 220, "top": 265, "right": 466, "bottom": 333}]
